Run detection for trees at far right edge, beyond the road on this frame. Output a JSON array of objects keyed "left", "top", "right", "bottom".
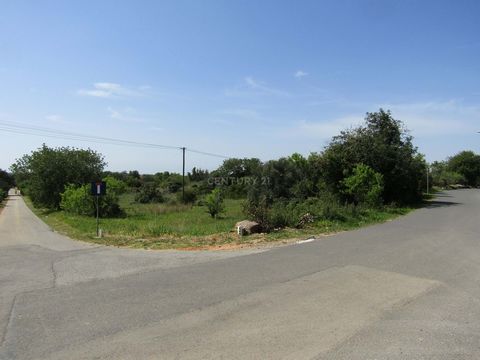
[{"left": 430, "top": 151, "right": 480, "bottom": 188}]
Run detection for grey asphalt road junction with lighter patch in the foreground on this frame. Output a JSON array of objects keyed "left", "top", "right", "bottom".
[{"left": 0, "top": 190, "right": 480, "bottom": 359}]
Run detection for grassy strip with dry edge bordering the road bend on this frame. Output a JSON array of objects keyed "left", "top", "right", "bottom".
[{"left": 25, "top": 194, "right": 413, "bottom": 249}]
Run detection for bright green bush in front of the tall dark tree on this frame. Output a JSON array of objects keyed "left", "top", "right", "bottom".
[{"left": 343, "top": 164, "right": 383, "bottom": 206}]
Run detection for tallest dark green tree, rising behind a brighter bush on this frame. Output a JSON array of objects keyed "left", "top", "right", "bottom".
[{"left": 320, "top": 109, "right": 426, "bottom": 203}]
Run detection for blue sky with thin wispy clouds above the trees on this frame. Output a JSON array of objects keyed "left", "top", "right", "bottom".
[{"left": 0, "top": 0, "right": 480, "bottom": 172}]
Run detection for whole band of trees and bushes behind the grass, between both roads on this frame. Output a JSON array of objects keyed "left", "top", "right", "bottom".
[{"left": 11, "top": 109, "right": 426, "bottom": 230}]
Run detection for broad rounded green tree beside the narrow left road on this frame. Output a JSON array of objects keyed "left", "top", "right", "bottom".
[{"left": 11, "top": 144, "right": 105, "bottom": 209}]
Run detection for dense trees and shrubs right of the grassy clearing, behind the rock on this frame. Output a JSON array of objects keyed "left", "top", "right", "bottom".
[{"left": 223, "top": 109, "right": 426, "bottom": 230}]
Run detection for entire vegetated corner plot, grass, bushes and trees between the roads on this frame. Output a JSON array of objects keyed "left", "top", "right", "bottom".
[{"left": 11, "top": 109, "right": 444, "bottom": 249}]
